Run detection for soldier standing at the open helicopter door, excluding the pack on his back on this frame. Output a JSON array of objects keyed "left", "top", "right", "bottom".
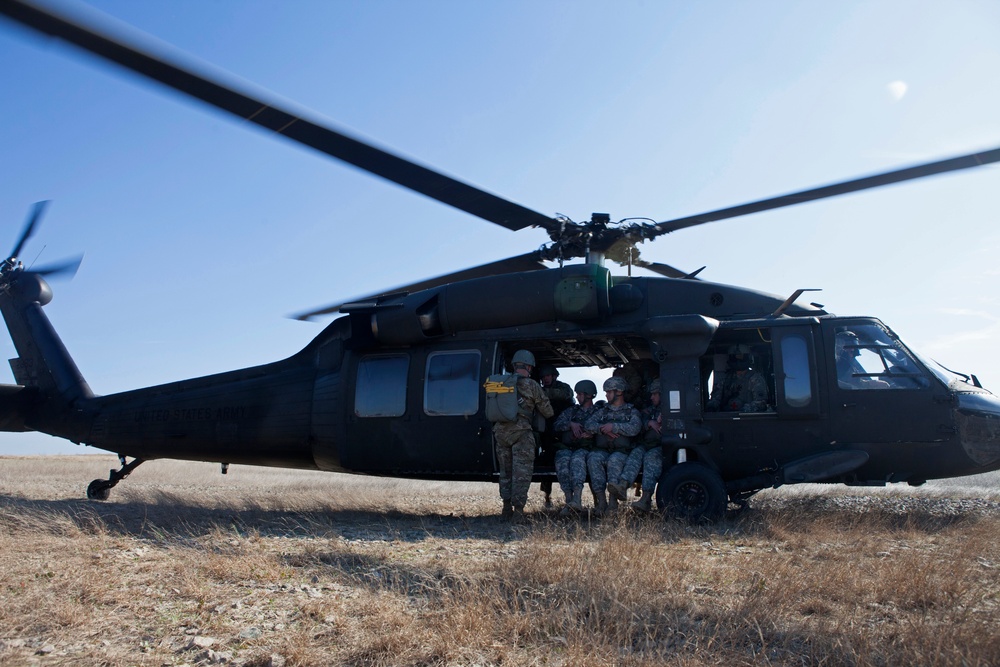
[{"left": 493, "top": 350, "right": 552, "bottom": 520}]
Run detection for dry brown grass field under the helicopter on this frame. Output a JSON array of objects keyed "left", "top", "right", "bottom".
[{"left": 0, "top": 456, "right": 1000, "bottom": 666}]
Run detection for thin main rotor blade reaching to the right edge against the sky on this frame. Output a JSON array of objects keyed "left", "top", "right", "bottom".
[{"left": 643, "top": 148, "right": 1000, "bottom": 238}]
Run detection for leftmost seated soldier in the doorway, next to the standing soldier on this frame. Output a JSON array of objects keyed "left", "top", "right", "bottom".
[{"left": 553, "top": 380, "right": 597, "bottom": 514}]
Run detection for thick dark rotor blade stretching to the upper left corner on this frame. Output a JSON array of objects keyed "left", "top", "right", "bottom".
[{"left": 0, "top": 0, "right": 559, "bottom": 231}]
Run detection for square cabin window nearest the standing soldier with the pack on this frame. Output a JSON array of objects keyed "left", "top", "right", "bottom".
[{"left": 424, "top": 350, "right": 482, "bottom": 416}]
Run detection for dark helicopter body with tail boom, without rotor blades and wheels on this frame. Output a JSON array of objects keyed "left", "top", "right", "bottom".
[{"left": 4, "top": 265, "right": 1000, "bottom": 496}]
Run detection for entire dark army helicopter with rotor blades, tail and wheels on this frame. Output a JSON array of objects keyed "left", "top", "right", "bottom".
[{"left": 0, "top": 0, "right": 1000, "bottom": 517}]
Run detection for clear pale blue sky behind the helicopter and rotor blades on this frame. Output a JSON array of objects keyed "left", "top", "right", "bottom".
[{"left": 0, "top": 0, "right": 1000, "bottom": 454}]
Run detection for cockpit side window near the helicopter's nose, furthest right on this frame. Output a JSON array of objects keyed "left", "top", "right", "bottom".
[{"left": 834, "top": 323, "right": 930, "bottom": 390}]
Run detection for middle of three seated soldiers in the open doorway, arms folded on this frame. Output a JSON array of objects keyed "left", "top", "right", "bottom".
[{"left": 584, "top": 377, "right": 642, "bottom": 514}]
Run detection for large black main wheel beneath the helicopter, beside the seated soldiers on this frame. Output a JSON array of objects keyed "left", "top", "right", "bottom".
[{"left": 656, "top": 461, "right": 729, "bottom": 523}]
